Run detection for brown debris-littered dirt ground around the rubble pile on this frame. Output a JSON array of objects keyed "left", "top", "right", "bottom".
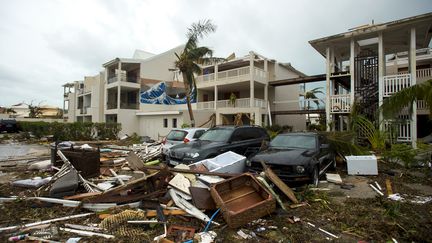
[{"left": 0, "top": 139, "right": 432, "bottom": 242}]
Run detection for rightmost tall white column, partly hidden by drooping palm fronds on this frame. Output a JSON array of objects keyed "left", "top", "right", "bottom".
[{"left": 409, "top": 28, "right": 417, "bottom": 148}]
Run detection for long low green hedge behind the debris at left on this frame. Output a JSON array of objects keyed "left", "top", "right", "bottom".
[{"left": 18, "top": 121, "right": 121, "bottom": 141}]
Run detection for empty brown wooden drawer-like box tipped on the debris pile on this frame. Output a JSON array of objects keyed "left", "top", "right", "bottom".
[{"left": 210, "top": 173, "right": 276, "bottom": 228}]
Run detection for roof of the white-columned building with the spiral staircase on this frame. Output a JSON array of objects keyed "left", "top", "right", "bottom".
[{"left": 309, "top": 13, "right": 432, "bottom": 58}]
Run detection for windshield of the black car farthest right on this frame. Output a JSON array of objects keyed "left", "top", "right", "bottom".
[{"left": 270, "top": 135, "right": 316, "bottom": 149}]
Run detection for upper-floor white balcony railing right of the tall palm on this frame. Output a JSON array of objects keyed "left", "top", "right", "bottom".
[{"left": 196, "top": 66, "right": 267, "bottom": 85}]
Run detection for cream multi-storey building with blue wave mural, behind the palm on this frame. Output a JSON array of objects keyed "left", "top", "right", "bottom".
[{"left": 63, "top": 46, "right": 305, "bottom": 139}]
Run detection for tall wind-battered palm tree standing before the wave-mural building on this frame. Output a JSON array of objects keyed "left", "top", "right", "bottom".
[{"left": 175, "top": 20, "right": 220, "bottom": 127}]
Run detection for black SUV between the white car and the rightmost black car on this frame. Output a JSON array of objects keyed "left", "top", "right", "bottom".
[{"left": 167, "top": 126, "right": 270, "bottom": 165}]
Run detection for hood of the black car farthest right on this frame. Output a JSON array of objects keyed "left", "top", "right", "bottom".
[{"left": 250, "top": 149, "right": 317, "bottom": 165}]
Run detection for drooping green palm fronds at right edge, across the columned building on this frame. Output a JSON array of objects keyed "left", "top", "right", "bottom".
[{"left": 381, "top": 79, "right": 432, "bottom": 118}]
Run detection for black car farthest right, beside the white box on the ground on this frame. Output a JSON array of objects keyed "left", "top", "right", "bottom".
[{"left": 246, "top": 132, "right": 336, "bottom": 185}]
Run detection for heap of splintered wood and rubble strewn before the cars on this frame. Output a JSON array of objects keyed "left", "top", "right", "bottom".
[{"left": 0, "top": 138, "right": 432, "bottom": 242}]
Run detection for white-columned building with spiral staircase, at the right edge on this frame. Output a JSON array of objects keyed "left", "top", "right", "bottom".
[{"left": 309, "top": 13, "right": 432, "bottom": 146}]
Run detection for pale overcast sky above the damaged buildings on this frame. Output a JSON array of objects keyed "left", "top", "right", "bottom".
[{"left": 0, "top": 0, "right": 432, "bottom": 106}]
